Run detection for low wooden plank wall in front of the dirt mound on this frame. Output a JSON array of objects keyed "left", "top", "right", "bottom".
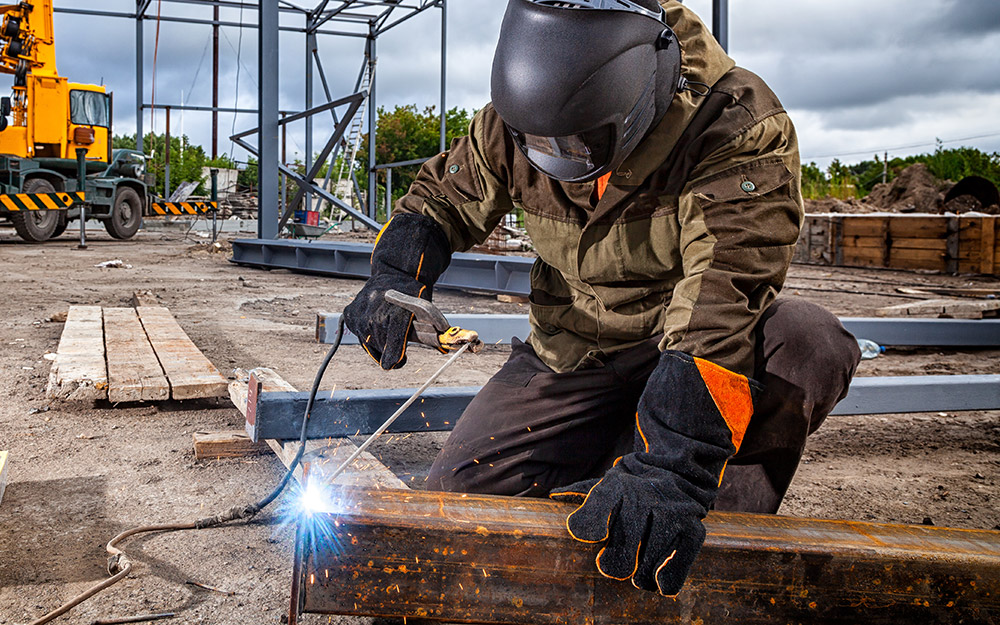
[{"left": 793, "top": 214, "right": 1000, "bottom": 275}]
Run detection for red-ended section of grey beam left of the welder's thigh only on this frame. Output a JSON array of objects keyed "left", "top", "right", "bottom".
[{"left": 246, "top": 386, "right": 479, "bottom": 442}]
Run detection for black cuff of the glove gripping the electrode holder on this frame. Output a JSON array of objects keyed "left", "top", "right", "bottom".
[{"left": 372, "top": 213, "right": 451, "bottom": 287}]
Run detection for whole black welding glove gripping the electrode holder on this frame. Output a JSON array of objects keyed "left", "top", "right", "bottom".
[{"left": 344, "top": 213, "right": 451, "bottom": 370}]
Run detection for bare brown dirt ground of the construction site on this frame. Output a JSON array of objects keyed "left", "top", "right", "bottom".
[{"left": 0, "top": 229, "right": 1000, "bottom": 625}]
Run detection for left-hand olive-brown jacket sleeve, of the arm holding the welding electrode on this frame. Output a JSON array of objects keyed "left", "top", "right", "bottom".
[{"left": 396, "top": 106, "right": 513, "bottom": 252}]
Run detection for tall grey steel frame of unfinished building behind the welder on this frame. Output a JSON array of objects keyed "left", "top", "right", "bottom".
[{"left": 55, "top": 0, "right": 729, "bottom": 239}]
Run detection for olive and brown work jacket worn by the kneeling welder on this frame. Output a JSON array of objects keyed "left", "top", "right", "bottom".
[{"left": 396, "top": 0, "right": 803, "bottom": 376}]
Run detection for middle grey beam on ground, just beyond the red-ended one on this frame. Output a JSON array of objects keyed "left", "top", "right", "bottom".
[{"left": 316, "top": 312, "right": 1000, "bottom": 347}]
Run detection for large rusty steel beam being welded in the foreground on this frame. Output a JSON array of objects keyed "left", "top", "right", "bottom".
[{"left": 292, "top": 489, "right": 1000, "bottom": 625}]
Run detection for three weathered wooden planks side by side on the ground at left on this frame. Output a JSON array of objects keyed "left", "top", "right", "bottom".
[{"left": 47, "top": 306, "right": 228, "bottom": 402}]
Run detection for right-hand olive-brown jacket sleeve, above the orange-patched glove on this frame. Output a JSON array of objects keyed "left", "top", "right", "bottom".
[{"left": 660, "top": 112, "right": 803, "bottom": 377}]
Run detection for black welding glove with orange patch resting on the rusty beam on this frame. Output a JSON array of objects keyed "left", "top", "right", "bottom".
[{"left": 551, "top": 351, "right": 759, "bottom": 596}]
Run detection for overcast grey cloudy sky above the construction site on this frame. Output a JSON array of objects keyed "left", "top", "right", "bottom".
[{"left": 55, "top": 0, "right": 1000, "bottom": 171}]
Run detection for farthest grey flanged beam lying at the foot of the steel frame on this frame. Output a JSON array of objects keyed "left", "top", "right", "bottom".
[{"left": 230, "top": 240, "right": 534, "bottom": 295}]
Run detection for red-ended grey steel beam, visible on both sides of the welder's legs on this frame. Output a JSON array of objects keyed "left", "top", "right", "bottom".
[{"left": 246, "top": 372, "right": 1000, "bottom": 441}]
